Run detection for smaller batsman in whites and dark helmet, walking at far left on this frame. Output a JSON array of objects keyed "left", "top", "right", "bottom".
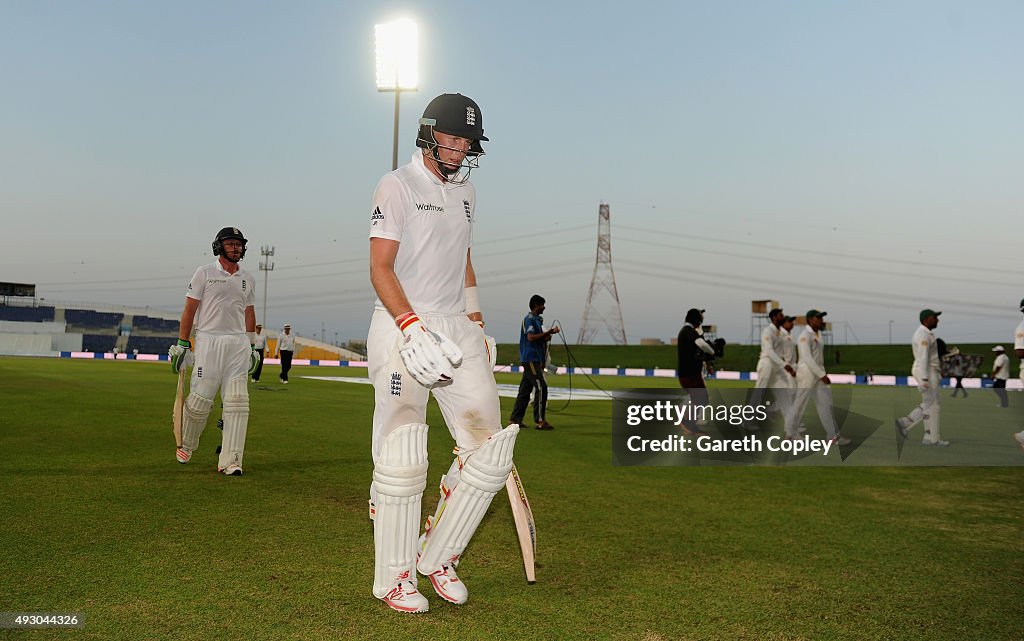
[{"left": 168, "top": 227, "right": 259, "bottom": 476}]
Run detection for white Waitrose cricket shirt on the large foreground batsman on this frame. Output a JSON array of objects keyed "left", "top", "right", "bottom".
[{"left": 370, "top": 149, "right": 476, "bottom": 314}]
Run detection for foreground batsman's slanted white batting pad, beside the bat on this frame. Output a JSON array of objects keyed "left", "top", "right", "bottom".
[{"left": 417, "top": 425, "right": 519, "bottom": 574}]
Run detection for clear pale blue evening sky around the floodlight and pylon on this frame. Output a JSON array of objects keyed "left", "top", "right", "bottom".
[{"left": 0, "top": 0, "right": 1024, "bottom": 342}]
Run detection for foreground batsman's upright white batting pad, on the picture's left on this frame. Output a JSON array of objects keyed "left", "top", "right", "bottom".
[{"left": 372, "top": 423, "right": 427, "bottom": 599}]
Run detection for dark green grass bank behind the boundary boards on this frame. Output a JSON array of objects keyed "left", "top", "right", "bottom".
[{"left": 498, "top": 334, "right": 1017, "bottom": 376}]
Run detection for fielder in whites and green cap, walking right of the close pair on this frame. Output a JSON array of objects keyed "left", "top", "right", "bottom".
[{"left": 896, "top": 309, "right": 949, "bottom": 445}]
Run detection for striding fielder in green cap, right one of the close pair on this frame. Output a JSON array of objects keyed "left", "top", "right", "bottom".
[{"left": 785, "top": 309, "right": 851, "bottom": 445}]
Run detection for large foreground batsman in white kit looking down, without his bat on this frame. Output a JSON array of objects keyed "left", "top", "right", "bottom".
[{"left": 367, "top": 93, "right": 519, "bottom": 612}]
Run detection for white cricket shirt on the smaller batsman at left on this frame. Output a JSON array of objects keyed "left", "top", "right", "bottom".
[{"left": 185, "top": 260, "right": 256, "bottom": 334}]
